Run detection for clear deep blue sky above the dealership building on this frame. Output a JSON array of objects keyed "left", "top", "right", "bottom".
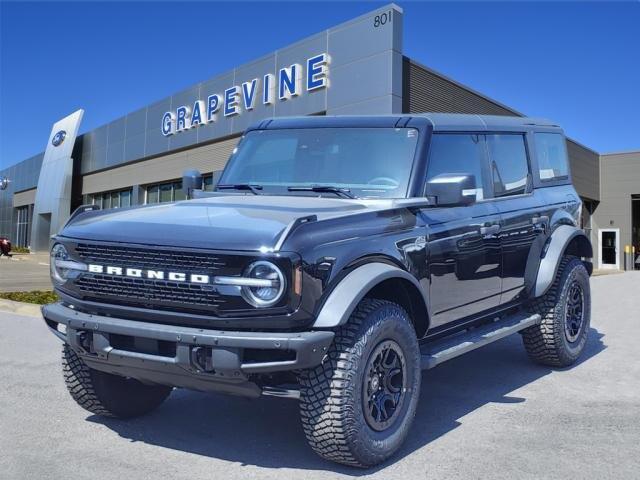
[{"left": 0, "top": 0, "right": 640, "bottom": 168}]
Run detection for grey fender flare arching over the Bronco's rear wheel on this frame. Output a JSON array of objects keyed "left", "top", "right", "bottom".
[{"left": 533, "top": 225, "right": 593, "bottom": 298}]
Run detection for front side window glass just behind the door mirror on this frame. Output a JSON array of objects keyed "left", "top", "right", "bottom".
[{"left": 426, "top": 133, "right": 484, "bottom": 200}]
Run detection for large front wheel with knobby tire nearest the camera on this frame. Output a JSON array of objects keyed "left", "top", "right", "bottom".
[{"left": 300, "top": 299, "right": 421, "bottom": 467}]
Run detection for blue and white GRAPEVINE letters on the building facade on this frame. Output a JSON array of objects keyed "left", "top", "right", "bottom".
[{"left": 161, "top": 53, "right": 329, "bottom": 137}]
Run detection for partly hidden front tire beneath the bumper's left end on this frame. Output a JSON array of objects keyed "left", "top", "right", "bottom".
[{"left": 62, "top": 344, "right": 172, "bottom": 418}]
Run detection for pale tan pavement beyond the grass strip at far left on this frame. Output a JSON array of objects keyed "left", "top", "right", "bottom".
[{"left": 0, "top": 253, "right": 51, "bottom": 292}]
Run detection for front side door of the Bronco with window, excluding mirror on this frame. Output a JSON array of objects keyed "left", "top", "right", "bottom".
[{"left": 421, "top": 133, "right": 502, "bottom": 327}]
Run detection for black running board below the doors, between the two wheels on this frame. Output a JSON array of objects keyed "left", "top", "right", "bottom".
[{"left": 421, "top": 313, "right": 540, "bottom": 370}]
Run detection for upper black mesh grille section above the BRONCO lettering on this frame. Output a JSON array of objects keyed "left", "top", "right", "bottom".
[{"left": 76, "top": 243, "right": 226, "bottom": 273}]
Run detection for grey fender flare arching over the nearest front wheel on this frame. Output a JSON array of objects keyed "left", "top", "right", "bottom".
[{"left": 313, "top": 262, "right": 428, "bottom": 328}]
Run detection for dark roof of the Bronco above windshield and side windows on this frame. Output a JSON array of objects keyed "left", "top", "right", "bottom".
[{"left": 249, "top": 113, "right": 559, "bottom": 131}]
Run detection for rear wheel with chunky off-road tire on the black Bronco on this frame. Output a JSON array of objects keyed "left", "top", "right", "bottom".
[{"left": 522, "top": 257, "right": 591, "bottom": 367}]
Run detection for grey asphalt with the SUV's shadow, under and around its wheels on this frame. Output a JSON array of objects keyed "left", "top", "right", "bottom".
[{"left": 0, "top": 272, "right": 640, "bottom": 480}]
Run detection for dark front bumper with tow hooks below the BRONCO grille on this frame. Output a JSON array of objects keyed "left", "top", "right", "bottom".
[{"left": 42, "top": 303, "right": 334, "bottom": 397}]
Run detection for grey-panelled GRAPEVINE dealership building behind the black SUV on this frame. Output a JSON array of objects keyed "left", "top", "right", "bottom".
[{"left": 0, "top": 4, "right": 640, "bottom": 268}]
